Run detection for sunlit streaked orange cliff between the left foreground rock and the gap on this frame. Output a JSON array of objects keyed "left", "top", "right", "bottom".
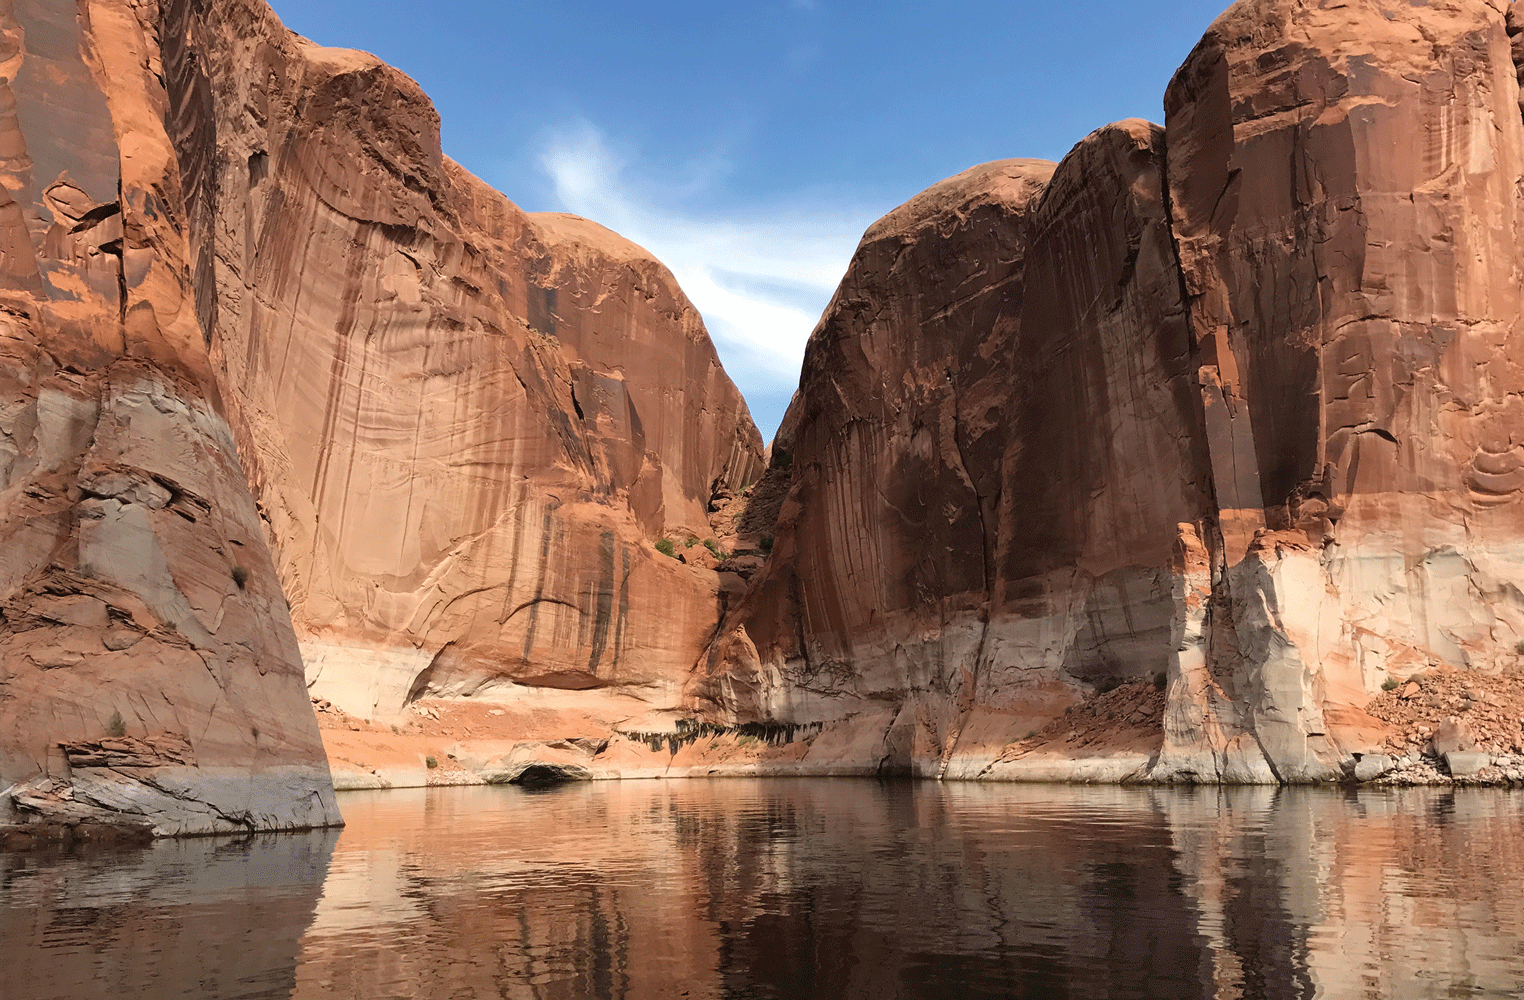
[{"left": 165, "top": 0, "right": 762, "bottom": 721}]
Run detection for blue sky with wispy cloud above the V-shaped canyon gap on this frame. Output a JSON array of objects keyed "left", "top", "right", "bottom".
[{"left": 273, "top": 0, "right": 1227, "bottom": 439}]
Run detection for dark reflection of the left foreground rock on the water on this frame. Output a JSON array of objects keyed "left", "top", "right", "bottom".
[{"left": 0, "top": 831, "right": 338, "bottom": 1000}]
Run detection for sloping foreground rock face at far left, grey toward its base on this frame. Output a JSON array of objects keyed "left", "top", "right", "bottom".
[{"left": 0, "top": 0, "right": 338, "bottom": 834}]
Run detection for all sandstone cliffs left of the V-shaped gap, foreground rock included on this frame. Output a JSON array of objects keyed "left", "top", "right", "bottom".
[{"left": 0, "top": 0, "right": 762, "bottom": 834}]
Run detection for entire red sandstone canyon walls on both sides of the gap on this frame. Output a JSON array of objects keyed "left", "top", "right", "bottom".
[{"left": 0, "top": 0, "right": 1524, "bottom": 834}]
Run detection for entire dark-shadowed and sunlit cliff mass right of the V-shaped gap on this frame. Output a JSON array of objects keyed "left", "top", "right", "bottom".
[{"left": 690, "top": 0, "right": 1524, "bottom": 782}]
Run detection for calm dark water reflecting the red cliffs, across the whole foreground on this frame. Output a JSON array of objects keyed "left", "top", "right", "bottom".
[{"left": 0, "top": 779, "right": 1524, "bottom": 1000}]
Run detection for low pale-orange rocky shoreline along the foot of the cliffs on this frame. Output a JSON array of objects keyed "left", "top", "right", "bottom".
[{"left": 319, "top": 701, "right": 1524, "bottom": 791}]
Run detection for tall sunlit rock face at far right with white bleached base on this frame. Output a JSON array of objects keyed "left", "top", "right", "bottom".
[{"left": 1161, "top": 0, "right": 1524, "bottom": 780}]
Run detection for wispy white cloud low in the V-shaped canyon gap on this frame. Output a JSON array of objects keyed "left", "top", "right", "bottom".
[{"left": 541, "top": 123, "right": 890, "bottom": 434}]
